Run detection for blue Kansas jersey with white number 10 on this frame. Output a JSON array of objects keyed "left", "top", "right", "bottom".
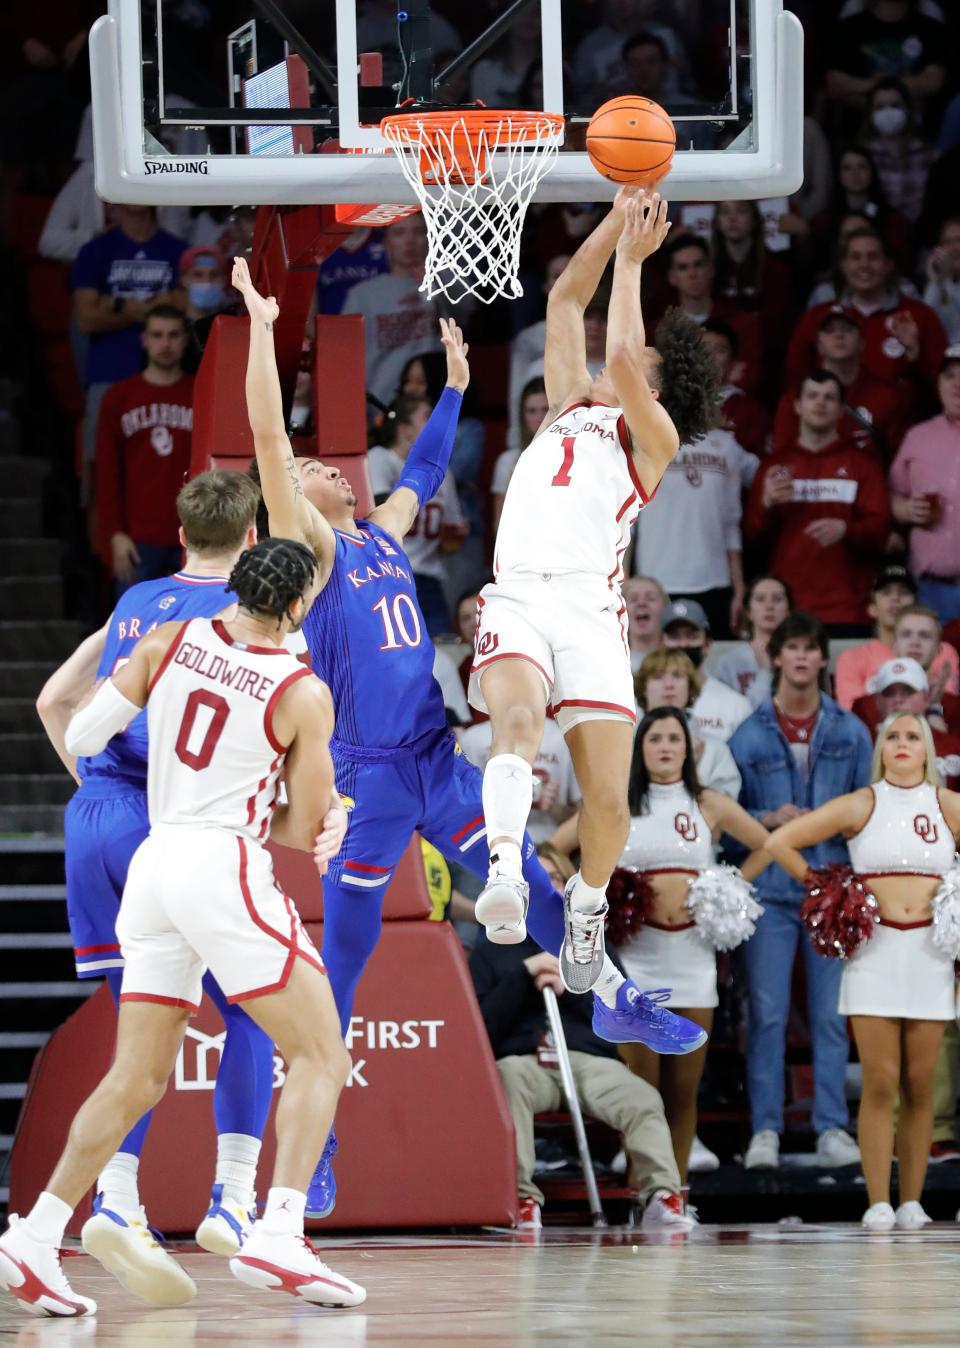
[{"left": 303, "top": 519, "right": 446, "bottom": 756}]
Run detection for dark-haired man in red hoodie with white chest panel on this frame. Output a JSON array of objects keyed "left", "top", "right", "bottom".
[{"left": 744, "top": 371, "right": 890, "bottom": 636}]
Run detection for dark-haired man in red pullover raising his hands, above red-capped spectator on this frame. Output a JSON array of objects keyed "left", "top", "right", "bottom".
[{"left": 786, "top": 229, "right": 947, "bottom": 396}]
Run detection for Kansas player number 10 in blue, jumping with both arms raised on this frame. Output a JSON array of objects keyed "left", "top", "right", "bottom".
[{"left": 232, "top": 257, "right": 702, "bottom": 1216}]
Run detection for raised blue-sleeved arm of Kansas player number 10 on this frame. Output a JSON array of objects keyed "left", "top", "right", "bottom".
[{"left": 369, "top": 318, "right": 471, "bottom": 539}]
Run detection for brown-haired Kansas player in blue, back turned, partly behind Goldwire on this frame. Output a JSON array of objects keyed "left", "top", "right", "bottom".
[{"left": 38, "top": 472, "right": 274, "bottom": 1283}]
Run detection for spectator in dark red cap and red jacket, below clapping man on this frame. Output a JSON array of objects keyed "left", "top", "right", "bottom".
[{"left": 774, "top": 305, "right": 906, "bottom": 462}]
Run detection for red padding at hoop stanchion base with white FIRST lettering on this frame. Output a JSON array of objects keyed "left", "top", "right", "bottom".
[{"left": 11, "top": 922, "right": 516, "bottom": 1233}]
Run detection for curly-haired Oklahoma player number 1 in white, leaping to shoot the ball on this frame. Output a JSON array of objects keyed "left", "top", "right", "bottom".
[{"left": 471, "top": 189, "right": 717, "bottom": 1013}]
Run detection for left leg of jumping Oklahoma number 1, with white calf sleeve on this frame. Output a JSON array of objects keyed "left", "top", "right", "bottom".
[{"left": 476, "top": 659, "right": 547, "bottom": 945}]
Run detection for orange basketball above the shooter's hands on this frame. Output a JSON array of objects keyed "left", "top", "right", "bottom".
[{"left": 587, "top": 94, "right": 677, "bottom": 187}]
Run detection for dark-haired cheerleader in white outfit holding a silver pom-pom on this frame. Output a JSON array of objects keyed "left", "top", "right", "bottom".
[{"left": 611, "top": 706, "right": 769, "bottom": 1184}]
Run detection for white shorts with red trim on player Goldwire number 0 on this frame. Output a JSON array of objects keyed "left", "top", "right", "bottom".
[{"left": 117, "top": 826, "right": 324, "bottom": 1010}]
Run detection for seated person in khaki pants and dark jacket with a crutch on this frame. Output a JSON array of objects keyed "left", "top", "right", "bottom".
[{"left": 471, "top": 845, "right": 696, "bottom": 1231}]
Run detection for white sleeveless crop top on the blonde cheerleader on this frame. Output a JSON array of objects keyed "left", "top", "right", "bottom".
[{"left": 847, "top": 782, "right": 956, "bottom": 880}]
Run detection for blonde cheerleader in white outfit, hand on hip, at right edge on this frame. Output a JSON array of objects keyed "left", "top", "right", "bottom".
[{"left": 767, "top": 712, "right": 960, "bottom": 1231}]
